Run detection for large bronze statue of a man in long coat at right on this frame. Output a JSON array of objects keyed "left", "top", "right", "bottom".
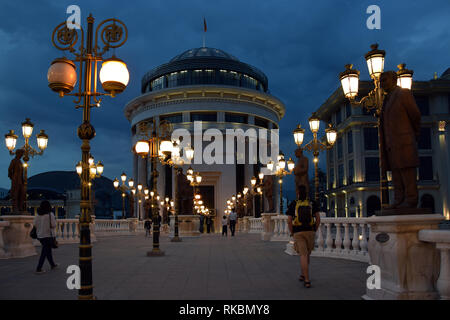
[{"left": 380, "top": 71, "right": 421, "bottom": 208}]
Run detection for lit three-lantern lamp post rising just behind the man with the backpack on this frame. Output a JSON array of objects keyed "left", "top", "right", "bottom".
[{"left": 293, "top": 112, "right": 337, "bottom": 201}]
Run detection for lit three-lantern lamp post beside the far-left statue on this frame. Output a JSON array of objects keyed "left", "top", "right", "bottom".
[{"left": 5, "top": 118, "right": 48, "bottom": 212}]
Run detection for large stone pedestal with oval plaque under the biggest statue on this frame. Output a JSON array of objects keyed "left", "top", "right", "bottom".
[{"left": 363, "top": 214, "right": 444, "bottom": 300}]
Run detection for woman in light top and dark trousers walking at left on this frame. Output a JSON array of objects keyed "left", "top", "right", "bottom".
[{"left": 33, "top": 200, "right": 58, "bottom": 274}]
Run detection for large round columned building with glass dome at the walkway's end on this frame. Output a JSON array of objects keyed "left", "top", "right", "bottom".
[{"left": 125, "top": 47, "right": 285, "bottom": 231}]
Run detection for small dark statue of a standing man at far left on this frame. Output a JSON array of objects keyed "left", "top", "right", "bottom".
[{"left": 8, "top": 149, "right": 26, "bottom": 213}]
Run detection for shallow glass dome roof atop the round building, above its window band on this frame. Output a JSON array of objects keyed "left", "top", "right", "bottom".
[{"left": 141, "top": 47, "right": 268, "bottom": 93}]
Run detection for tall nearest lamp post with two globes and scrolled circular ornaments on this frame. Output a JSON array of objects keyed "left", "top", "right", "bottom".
[{"left": 47, "top": 15, "right": 129, "bottom": 300}]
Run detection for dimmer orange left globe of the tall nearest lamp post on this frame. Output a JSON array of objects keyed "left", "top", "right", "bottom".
[{"left": 47, "top": 58, "right": 77, "bottom": 97}]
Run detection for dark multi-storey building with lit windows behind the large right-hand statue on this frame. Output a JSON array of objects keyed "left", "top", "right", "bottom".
[{"left": 317, "top": 69, "right": 450, "bottom": 218}]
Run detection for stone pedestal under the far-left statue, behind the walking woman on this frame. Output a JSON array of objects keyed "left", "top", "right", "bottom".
[{"left": 1, "top": 215, "right": 37, "bottom": 258}]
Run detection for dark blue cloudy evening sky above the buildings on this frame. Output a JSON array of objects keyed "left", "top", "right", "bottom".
[{"left": 0, "top": 0, "right": 450, "bottom": 199}]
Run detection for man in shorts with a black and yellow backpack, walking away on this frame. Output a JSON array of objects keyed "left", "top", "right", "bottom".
[{"left": 286, "top": 185, "right": 320, "bottom": 288}]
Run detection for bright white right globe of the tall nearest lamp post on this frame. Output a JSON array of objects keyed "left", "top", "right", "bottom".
[{"left": 99, "top": 56, "right": 130, "bottom": 96}]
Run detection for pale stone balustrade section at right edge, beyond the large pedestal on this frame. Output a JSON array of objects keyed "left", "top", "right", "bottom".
[{"left": 419, "top": 230, "right": 450, "bottom": 300}]
